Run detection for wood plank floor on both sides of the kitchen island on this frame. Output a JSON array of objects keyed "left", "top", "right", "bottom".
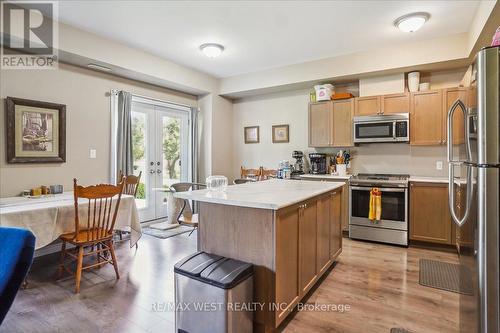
[{"left": 0, "top": 234, "right": 458, "bottom": 333}]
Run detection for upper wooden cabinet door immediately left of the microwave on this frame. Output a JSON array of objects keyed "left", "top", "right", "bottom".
[{"left": 332, "top": 98, "right": 354, "bottom": 147}]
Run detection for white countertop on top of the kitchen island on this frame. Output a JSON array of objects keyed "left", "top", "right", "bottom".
[{"left": 174, "top": 179, "right": 344, "bottom": 210}]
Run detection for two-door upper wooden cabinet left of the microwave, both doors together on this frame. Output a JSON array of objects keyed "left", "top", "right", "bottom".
[{"left": 309, "top": 98, "right": 354, "bottom": 147}]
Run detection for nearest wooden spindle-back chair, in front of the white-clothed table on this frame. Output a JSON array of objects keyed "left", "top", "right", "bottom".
[{"left": 59, "top": 178, "right": 125, "bottom": 294}]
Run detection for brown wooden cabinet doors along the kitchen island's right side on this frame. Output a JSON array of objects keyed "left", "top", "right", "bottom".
[{"left": 274, "top": 188, "right": 342, "bottom": 326}]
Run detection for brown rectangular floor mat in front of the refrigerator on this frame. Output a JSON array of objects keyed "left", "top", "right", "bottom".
[{"left": 419, "top": 259, "right": 472, "bottom": 295}]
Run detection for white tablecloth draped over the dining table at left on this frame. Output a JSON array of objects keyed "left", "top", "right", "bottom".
[{"left": 0, "top": 192, "right": 142, "bottom": 249}]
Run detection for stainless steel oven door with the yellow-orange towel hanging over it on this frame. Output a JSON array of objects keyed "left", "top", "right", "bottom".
[{"left": 349, "top": 186, "right": 408, "bottom": 230}]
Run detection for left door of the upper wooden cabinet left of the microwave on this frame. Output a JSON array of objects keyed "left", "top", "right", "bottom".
[{"left": 309, "top": 101, "right": 333, "bottom": 147}]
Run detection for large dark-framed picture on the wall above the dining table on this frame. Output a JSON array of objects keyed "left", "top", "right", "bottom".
[{"left": 5, "top": 97, "right": 66, "bottom": 163}]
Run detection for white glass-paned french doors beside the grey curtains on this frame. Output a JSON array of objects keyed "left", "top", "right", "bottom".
[{"left": 132, "top": 98, "right": 191, "bottom": 222}]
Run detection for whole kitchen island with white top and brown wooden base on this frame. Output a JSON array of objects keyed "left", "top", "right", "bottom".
[{"left": 175, "top": 180, "right": 344, "bottom": 332}]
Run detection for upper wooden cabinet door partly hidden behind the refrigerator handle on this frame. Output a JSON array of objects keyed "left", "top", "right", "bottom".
[{"left": 443, "top": 88, "right": 467, "bottom": 144}]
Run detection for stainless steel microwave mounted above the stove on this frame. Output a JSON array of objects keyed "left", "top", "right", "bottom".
[{"left": 353, "top": 113, "right": 410, "bottom": 143}]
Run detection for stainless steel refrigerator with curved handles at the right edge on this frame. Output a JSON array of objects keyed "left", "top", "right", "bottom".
[{"left": 447, "top": 47, "right": 500, "bottom": 333}]
